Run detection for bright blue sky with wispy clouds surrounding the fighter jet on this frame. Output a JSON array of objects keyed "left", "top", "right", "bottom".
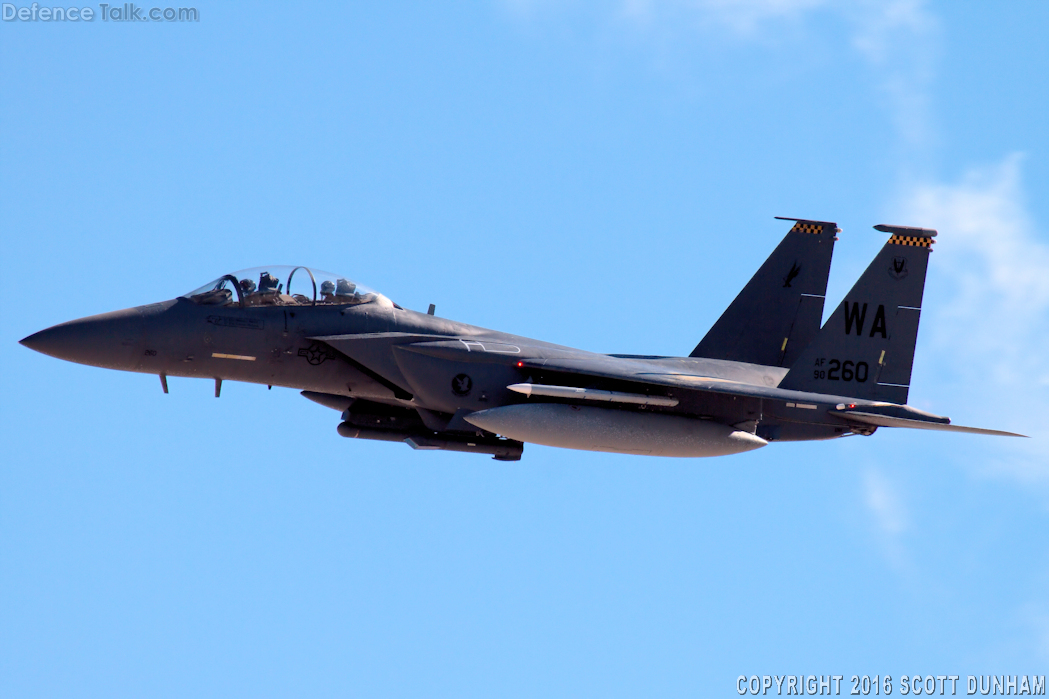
[{"left": 0, "top": 0, "right": 1049, "bottom": 697}]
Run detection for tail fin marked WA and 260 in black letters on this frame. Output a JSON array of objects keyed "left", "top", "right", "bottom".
[{"left": 779, "top": 226, "right": 936, "bottom": 404}]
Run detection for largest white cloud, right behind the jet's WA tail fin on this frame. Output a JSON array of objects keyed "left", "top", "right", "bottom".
[{"left": 896, "top": 154, "right": 1049, "bottom": 483}]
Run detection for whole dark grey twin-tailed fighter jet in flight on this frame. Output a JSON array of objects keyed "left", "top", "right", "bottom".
[{"left": 21, "top": 218, "right": 1022, "bottom": 461}]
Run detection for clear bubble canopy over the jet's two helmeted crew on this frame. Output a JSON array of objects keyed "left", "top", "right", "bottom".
[{"left": 183, "top": 266, "right": 393, "bottom": 308}]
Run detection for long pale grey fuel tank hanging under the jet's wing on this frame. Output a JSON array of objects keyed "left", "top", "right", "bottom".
[{"left": 465, "top": 403, "right": 768, "bottom": 457}]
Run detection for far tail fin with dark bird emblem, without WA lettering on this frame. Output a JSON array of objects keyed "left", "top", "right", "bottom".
[{"left": 689, "top": 216, "right": 839, "bottom": 366}]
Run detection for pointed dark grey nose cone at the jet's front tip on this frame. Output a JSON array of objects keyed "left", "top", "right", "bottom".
[{"left": 20, "top": 309, "right": 145, "bottom": 369}]
